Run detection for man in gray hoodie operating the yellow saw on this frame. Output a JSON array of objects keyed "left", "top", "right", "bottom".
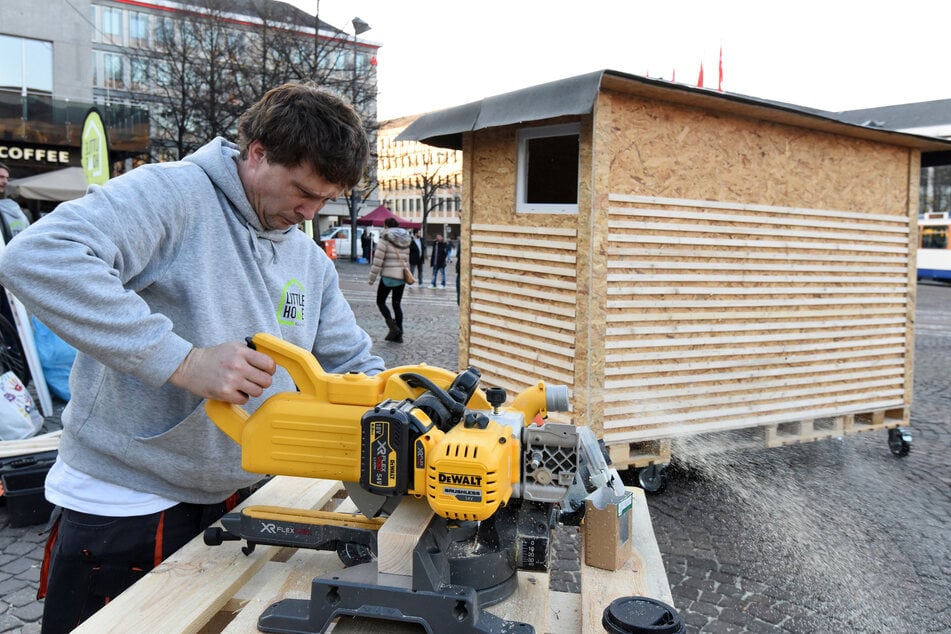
[{"left": 0, "top": 84, "right": 384, "bottom": 633}]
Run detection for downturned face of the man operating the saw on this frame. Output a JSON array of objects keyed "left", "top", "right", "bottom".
[{"left": 242, "top": 141, "right": 343, "bottom": 229}]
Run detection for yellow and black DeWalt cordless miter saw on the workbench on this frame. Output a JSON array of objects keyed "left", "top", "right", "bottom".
[{"left": 205, "top": 334, "right": 629, "bottom": 634}]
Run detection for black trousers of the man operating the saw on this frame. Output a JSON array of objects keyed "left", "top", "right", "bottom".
[{"left": 37, "top": 491, "right": 249, "bottom": 634}]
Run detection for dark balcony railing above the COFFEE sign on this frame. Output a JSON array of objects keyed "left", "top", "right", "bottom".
[{"left": 0, "top": 89, "right": 149, "bottom": 153}]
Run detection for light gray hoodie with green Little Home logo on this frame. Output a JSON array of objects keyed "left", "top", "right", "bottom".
[{"left": 0, "top": 139, "right": 384, "bottom": 503}]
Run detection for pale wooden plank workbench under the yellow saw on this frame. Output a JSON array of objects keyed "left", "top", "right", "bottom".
[{"left": 74, "top": 476, "right": 673, "bottom": 634}]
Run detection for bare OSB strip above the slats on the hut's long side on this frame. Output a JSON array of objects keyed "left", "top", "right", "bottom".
[{"left": 601, "top": 91, "right": 910, "bottom": 215}]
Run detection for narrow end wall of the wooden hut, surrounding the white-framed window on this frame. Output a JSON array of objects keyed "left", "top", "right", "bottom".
[{"left": 460, "top": 117, "right": 604, "bottom": 420}]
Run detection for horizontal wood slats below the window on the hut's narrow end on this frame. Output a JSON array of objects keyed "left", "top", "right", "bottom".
[{"left": 468, "top": 223, "right": 578, "bottom": 412}]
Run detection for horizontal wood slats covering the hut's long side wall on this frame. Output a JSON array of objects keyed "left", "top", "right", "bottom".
[{"left": 604, "top": 194, "right": 913, "bottom": 443}]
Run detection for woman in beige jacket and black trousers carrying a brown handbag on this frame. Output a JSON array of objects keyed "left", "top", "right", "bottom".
[{"left": 369, "top": 218, "right": 413, "bottom": 343}]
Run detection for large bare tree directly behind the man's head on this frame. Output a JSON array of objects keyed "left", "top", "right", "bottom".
[{"left": 147, "top": 0, "right": 376, "bottom": 163}]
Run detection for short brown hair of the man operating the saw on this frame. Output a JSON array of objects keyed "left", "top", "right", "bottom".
[{"left": 238, "top": 83, "right": 370, "bottom": 189}]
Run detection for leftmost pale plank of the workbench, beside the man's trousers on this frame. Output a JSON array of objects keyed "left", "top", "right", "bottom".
[{"left": 74, "top": 476, "right": 340, "bottom": 634}]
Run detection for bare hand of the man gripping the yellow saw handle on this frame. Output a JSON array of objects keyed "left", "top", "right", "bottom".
[{"left": 169, "top": 341, "right": 277, "bottom": 405}]
